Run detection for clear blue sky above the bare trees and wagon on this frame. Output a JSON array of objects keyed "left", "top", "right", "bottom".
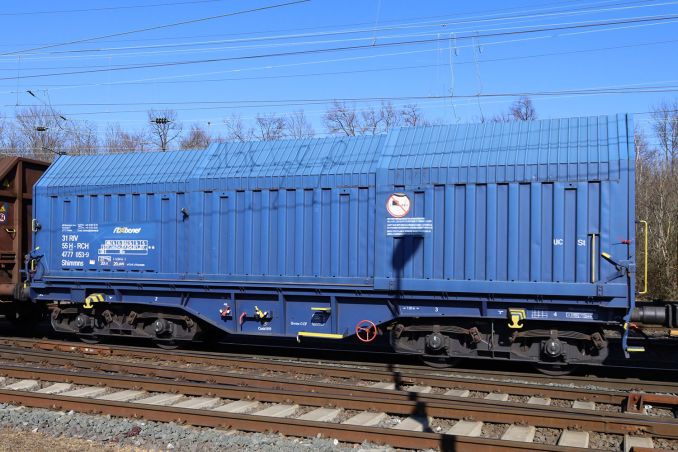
[{"left": 0, "top": 0, "right": 678, "bottom": 139}]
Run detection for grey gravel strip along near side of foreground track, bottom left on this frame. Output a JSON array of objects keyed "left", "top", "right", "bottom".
[{"left": 0, "top": 404, "right": 374, "bottom": 452}]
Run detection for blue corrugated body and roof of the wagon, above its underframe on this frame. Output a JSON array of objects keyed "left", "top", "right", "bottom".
[{"left": 31, "top": 116, "right": 633, "bottom": 293}]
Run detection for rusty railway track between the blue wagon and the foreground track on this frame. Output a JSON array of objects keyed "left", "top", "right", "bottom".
[{"left": 2, "top": 339, "right": 678, "bottom": 415}]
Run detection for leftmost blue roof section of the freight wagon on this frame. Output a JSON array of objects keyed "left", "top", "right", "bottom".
[{"left": 36, "top": 151, "right": 206, "bottom": 193}]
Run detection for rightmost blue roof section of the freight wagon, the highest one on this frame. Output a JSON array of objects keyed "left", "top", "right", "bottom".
[{"left": 379, "top": 115, "right": 629, "bottom": 184}]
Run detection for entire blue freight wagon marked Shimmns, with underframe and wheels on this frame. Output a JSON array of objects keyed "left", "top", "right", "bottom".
[{"left": 27, "top": 115, "right": 635, "bottom": 370}]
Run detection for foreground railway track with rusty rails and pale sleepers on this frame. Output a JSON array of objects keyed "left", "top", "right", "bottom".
[{"left": 0, "top": 365, "right": 678, "bottom": 450}]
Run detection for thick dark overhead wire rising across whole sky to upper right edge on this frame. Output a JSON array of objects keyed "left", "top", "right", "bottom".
[{"left": 0, "top": 12, "right": 678, "bottom": 80}]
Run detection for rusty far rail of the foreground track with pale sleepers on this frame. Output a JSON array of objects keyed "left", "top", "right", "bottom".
[{"left": 0, "top": 358, "right": 678, "bottom": 439}]
